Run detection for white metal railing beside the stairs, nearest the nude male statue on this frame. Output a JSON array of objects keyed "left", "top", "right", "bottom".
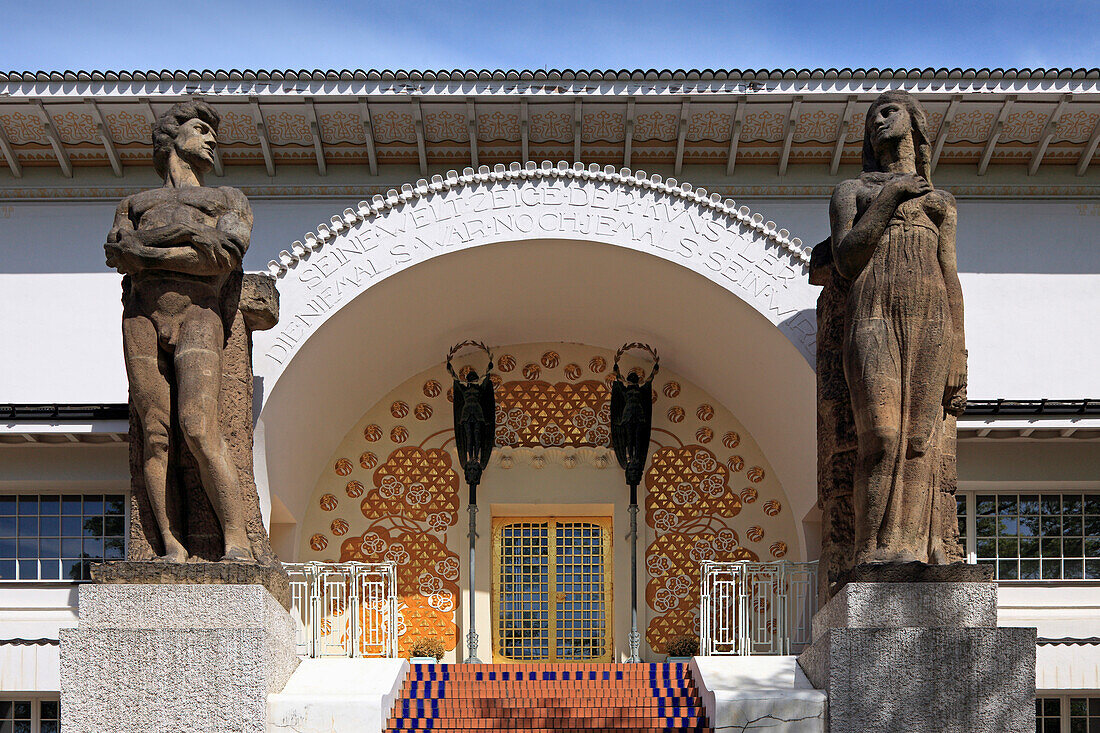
[{"left": 283, "top": 562, "right": 397, "bottom": 657}]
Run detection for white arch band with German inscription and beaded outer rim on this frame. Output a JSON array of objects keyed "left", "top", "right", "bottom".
[{"left": 256, "top": 163, "right": 816, "bottom": 384}]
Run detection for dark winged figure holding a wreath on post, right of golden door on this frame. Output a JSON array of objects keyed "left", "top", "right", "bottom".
[{"left": 611, "top": 341, "right": 661, "bottom": 661}]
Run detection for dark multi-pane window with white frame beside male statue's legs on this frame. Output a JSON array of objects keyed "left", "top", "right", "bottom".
[{"left": 0, "top": 494, "right": 127, "bottom": 581}]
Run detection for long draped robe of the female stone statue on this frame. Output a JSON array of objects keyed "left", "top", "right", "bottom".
[{"left": 844, "top": 188, "right": 955, "bottom": 562}]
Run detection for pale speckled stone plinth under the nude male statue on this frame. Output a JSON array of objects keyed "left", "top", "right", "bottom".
[{"left": 61, "top": 583, "right": 298, "bottom": 733}]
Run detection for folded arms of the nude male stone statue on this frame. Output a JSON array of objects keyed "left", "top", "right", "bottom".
[{"left": 106, "top": 187, "right": 252, "bottom": 275}]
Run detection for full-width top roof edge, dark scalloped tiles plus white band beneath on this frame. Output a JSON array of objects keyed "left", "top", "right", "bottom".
[{"left": 0, "top": 68, "right": 1100, "bottom": 101}]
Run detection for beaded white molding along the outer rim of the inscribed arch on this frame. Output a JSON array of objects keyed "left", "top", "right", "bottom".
[{"left": 267, "top": 161, "right": 812, "bottom": 278}]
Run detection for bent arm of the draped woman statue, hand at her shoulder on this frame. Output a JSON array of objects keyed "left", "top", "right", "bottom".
[{"left": 829, "top": 174, "right": 932, "bottom": 280}]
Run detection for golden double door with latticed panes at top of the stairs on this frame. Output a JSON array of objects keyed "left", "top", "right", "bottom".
[{"left": 492, "top": 516, "right": 613, "bottom": 661}]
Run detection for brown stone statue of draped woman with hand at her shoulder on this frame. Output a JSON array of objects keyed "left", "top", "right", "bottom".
[{"left": 829, "top": 91, "right": 966, "bottom": 565}]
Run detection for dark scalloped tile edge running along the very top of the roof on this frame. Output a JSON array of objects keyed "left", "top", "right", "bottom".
[{"left": 0, "top": 67, "right": 1100, "bottom": 81}]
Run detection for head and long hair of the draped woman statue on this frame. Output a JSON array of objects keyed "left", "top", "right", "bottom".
[{"left": 864, "top": 89, "right": 932, "bottom": 182}]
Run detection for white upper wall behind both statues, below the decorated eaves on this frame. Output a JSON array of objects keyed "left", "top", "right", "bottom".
[{"left": 0, "top": 166, "right": 1100, "bottom": 403}]
